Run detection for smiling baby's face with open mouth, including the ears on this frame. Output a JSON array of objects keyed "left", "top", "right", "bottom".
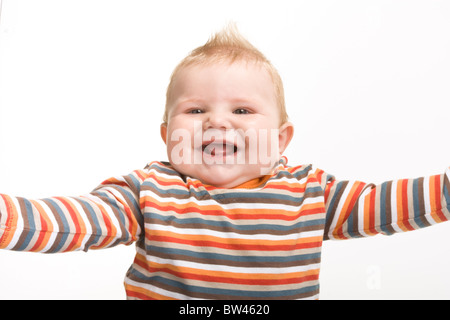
[{"left": 161, "top": 62, "right": 293, "bottom": 188}]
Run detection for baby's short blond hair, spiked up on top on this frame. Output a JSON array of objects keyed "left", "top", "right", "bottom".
[{"left": 163, "top": 24, "right": 288, "bottom": 124}]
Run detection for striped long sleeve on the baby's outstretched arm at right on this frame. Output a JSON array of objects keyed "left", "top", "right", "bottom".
[{"left": 321, "top": 169, "right": 450, "bottom": 239}]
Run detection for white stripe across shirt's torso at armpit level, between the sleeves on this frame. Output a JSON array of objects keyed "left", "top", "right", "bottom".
[{"left": 145, "top": 223, "right": 323, "bottom": 241}]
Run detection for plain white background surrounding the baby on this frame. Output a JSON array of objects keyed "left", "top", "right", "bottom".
[{"left": 0, "top": 0, "right": 450, "bottom": 299}]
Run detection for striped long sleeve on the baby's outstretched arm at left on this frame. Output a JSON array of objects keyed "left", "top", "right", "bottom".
[{"left": 0, "top": 171, "right": 145, "bottom": 253}]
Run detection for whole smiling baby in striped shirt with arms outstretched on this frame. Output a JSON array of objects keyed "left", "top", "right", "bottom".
[{"left": 0, "top": 28, "right": 450, "bottom": 299}]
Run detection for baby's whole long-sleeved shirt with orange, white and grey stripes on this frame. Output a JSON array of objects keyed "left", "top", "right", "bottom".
[{"left": 0, "top": 158, "right": 450, "bottom": 299}]
